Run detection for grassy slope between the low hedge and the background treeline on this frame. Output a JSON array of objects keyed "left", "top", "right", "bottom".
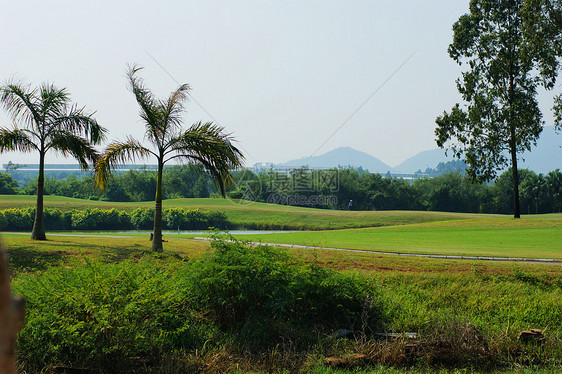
[{"left": 0, "top": 195, "right": 483, "bottom": 230}]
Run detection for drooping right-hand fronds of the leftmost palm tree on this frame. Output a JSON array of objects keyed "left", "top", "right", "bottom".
[{"left": 46, "top": 131, "right": 99, "bottom": 170}]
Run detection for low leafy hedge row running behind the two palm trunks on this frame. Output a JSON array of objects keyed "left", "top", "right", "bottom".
[{"left": 0, "top": 208, "right": 232, "bottom": 231}]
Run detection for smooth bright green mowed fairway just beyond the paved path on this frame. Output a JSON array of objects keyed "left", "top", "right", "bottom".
[{"left": 236, "top": 215, "right": 562, "bottom": 259}]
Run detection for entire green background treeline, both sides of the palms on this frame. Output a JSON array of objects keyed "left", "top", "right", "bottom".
[{"left": 0, "top": 163, "right": 562, "bottom": 214}]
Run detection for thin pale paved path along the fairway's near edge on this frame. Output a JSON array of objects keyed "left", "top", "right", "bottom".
[{"left": 193, "top": 237, "right": 562, "bottom": 264}]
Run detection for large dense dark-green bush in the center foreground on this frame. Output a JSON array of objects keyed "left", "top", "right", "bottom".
[{"left": 191, "top": 240, "right": 381, "bottom": 347}]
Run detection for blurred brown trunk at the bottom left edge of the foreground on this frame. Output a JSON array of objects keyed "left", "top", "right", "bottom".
[{"left": 0, "top": 241, "right": 25, "bottom": 374}]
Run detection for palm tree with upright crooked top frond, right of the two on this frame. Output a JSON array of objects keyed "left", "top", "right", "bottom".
[{"left": 95, "top": 65, "right": 244, "bottom": 252}]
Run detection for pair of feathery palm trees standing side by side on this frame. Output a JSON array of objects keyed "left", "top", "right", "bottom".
[{"left": 0, "top": 66, "right": 243, "bottom": 252}]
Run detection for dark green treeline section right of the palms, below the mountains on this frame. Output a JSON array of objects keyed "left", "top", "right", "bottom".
[{"left": 230, "top": 169, "right": 562, "bottom": 214}]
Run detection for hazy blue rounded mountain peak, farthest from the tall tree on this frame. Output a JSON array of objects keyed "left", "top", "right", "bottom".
[{"left": 276, "top": 147, "right": 391, "bottom": 173}]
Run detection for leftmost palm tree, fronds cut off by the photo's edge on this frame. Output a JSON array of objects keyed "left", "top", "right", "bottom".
[{"left": 0, "top": 82, "right": 106, "bottom": 240}]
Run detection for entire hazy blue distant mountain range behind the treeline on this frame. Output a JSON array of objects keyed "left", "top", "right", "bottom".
[{"left": 276, "top": 126, "right": 562, "bottom": 174}]
